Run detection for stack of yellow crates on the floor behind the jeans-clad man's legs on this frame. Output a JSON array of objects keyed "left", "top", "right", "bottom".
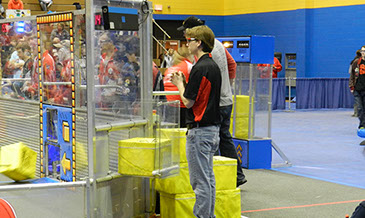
[{"left": 156, "top": 129, "right": 241, "bottom": 218}]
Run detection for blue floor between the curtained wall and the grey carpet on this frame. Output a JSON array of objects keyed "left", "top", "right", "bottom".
[{"left": 272, "top": 109, "right": 365, "bottom": 189}]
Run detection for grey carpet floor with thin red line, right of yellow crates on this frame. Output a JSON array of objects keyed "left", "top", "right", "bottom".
[{"left": 240, "top": 170, "right": 365, "bottom": 218}]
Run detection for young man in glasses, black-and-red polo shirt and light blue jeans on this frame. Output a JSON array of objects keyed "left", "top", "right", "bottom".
[{"left": 171, "top": 26, "right": 222, "bottom": 218}]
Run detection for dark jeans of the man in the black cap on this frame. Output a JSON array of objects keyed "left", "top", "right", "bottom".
[{"left": 216, "top": 105, "right": 245, "bottom": 181}]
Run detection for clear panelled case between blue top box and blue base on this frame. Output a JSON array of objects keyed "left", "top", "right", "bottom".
[{"left": 232, "top": 63, "right": 272, "bottom": 139}]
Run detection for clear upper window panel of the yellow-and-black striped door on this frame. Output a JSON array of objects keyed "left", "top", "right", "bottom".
[{"left": 38, "top": 21, "right": 73, "bottom": 107}]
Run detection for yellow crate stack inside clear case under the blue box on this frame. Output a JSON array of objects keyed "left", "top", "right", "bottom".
[{"left": 230, "top": 95, "right": 252, "bottom": 139}]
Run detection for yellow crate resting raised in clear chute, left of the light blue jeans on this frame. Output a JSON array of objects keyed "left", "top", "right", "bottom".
[{"left": 118, "top": 138, "right": 172, "bottom": 177}]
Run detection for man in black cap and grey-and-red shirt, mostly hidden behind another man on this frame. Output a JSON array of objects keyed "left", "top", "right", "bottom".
[{"left": 177, "top": 16, "right": 247, "bottom": 187}]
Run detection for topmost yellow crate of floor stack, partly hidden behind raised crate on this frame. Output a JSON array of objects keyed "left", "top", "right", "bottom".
[{"left": 161, "top": 128, "right": 187, "bottom": 163}]
